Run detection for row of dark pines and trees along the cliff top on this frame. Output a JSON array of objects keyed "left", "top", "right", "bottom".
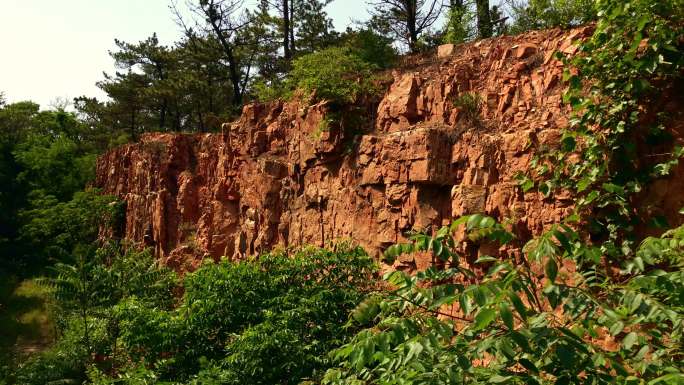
[{"left": 74, "top": 0, "right": 595, "bottom": 140}]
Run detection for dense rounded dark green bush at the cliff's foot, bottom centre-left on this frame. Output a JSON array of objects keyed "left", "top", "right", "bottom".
[{"left": 117, "top": 246, "right": 374, "bottom": 384}]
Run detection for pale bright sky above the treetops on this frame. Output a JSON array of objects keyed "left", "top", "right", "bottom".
[{"left": 0, "top": 0, "right": 367, "bottom": 109}]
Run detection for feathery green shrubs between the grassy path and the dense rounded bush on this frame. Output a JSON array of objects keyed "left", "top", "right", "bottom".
[{"left": 16, "top": 243, "right": 177, "bottom": 385}]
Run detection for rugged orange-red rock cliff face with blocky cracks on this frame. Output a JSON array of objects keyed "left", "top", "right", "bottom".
[{"left": 96, "top": 28, "right": 684, "bottom": 269}]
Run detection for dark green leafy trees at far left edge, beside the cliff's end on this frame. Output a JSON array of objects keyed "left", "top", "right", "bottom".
[{"left": 0, "top": 102, "right": 112, "bottom": 268}]
